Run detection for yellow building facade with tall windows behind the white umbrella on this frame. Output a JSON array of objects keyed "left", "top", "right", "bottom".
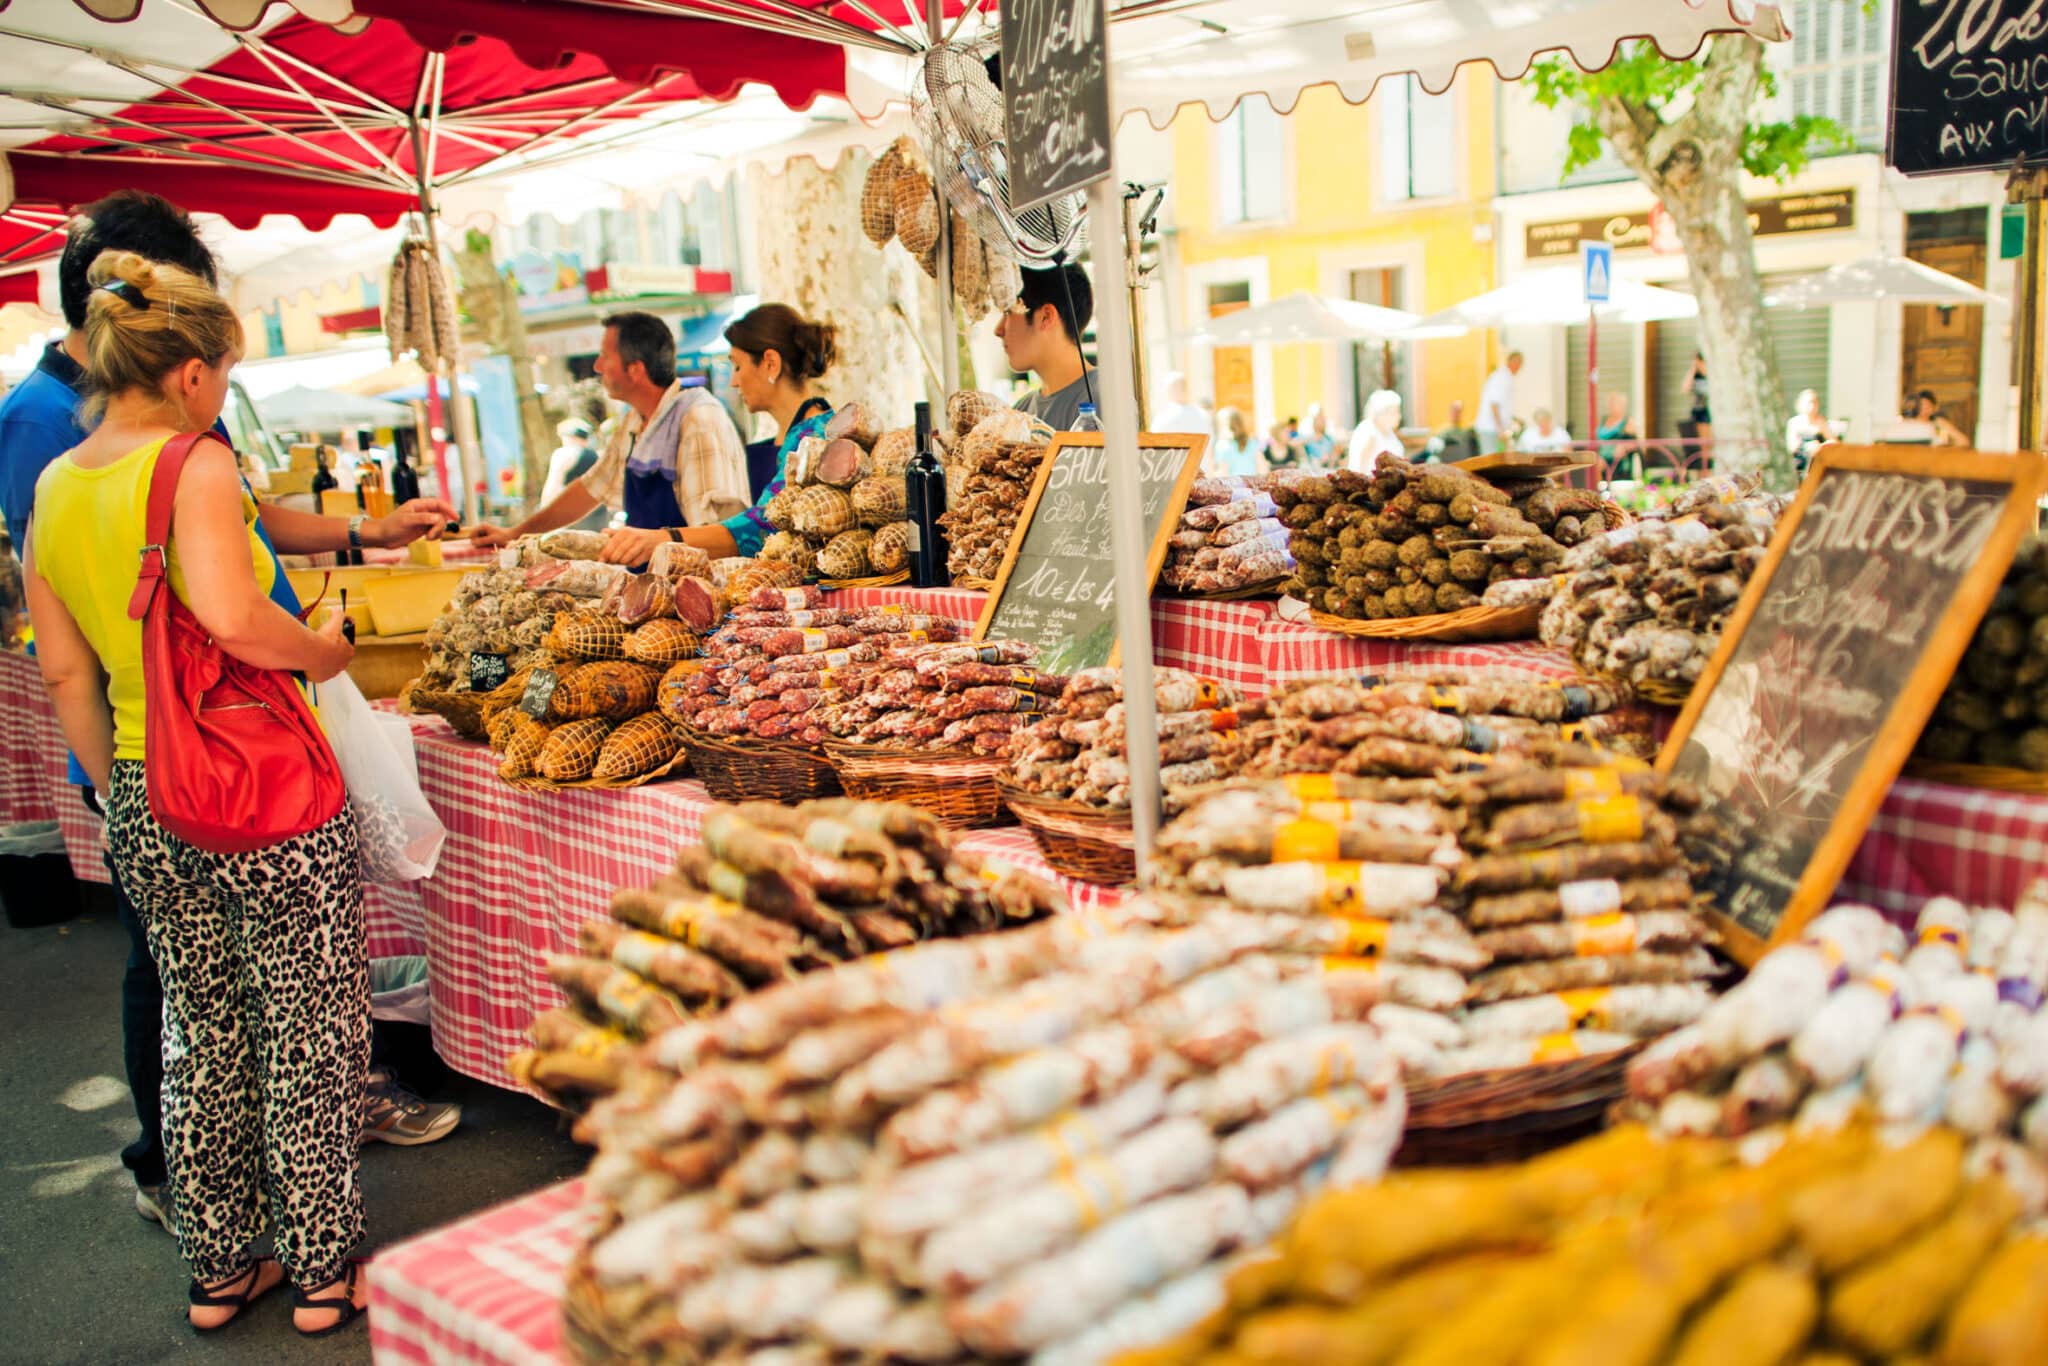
[{"left": 1169, "top": 68, "right": 1499, "bottom": 430}]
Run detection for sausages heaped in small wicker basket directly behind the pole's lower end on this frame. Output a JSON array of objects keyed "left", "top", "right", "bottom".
[{"left": 1010, "top": 668, "right": 1247, "bottom": 809}]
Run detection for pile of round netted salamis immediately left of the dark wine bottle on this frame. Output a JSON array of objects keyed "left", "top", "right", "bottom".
[{"left": 762, "top": 403, "right": 913, "bottom": 580}]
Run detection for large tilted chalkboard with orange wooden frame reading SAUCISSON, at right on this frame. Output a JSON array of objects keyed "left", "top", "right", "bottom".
[{"left": 1657, "top": 446, "right": 2048, "bottom": 963}]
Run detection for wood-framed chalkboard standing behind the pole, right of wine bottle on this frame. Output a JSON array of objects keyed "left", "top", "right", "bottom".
[{"left": 975, "top": 432, "right": 1208, "bottom": 674}]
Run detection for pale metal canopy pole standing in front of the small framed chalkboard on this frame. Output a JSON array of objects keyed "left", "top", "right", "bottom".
[{"left": 1087, "top": 77, "right": 1159, "bottom": 877}]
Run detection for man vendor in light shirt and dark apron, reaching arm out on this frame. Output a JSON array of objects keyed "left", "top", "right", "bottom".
[{"left": 471, "top": 313, "right": 748, "bottom": 567}]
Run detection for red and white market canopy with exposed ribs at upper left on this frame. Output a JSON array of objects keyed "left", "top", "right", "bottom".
[{"left": 0, "top": 0, "right": 846, "bottom": 303}]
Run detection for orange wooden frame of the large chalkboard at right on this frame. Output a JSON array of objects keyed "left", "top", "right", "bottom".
[{"left": 1657, "top": 446, "right": 2048, "bottom": 967}]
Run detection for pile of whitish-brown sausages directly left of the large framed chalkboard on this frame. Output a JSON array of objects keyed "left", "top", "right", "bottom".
[{"left": 1485, "top": 479, "right": 1786, "bottom": 688}]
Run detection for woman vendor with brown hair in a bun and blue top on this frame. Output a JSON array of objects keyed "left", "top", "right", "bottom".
[{"left": 672, "top": 303, "right": 838, "bottom": 559}]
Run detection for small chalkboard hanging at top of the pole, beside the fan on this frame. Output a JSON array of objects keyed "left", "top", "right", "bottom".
[{"left": 1004, "top": 0, "right": 1110, "bottom": 209}]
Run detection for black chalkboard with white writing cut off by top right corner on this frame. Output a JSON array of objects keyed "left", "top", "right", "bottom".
[{"left": 1884, "top": 0, "right": 2048, "bottom": 176}]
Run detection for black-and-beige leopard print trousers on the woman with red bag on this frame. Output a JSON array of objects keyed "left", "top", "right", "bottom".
[{"left": 106, "top": 760, "right": 371, "bottom": 1288}]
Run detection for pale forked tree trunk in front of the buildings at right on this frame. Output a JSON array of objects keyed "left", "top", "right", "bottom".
[{"left": 1593, "top": 35, "right": 1796, "bottom": 487}]
